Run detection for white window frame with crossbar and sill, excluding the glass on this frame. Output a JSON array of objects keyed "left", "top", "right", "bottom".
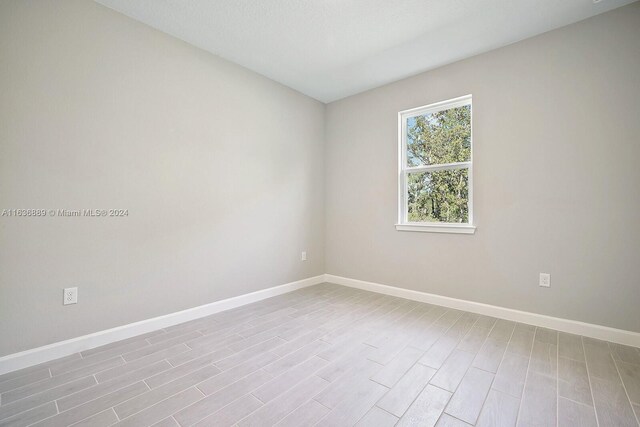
[{"left": 396, "top": 95, "right": 476, "bottom": 234}]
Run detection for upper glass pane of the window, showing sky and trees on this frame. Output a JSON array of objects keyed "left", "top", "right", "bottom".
[{"left": 407, "top": 105, "right": 471, "bottom": 166}]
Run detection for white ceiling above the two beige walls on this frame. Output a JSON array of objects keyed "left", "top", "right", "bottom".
[{"left": 96, "top": 0, "right": 634, "bottom": 102}]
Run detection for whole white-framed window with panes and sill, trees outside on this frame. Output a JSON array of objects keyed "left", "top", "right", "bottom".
[{"left": 396, "top": 95, "right": 475, "bottom": 234}]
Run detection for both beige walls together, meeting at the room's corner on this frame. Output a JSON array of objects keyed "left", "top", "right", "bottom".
[{"left": 0, "top": 0, "right": 640, "bottom": 356}]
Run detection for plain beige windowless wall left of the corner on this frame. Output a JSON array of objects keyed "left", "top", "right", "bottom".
[{"left": 0, "top": 0, "right": 324, "bottom": 356}]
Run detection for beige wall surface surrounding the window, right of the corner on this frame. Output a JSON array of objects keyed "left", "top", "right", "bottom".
[{"left": 325, "top": 3, "right": 640, "bottom": 331}]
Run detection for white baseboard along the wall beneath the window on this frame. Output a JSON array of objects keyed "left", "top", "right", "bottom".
[{"left": 324, "top": 274, "right": 640, "bottom": 347}]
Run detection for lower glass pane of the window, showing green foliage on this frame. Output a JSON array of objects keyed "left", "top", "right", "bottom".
[{"left": 407, "top": 169, "right": 469, "bottom": 223}]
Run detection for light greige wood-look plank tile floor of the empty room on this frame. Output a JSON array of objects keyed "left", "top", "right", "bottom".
[{"left": 0, "top": 284, "right": 640, "bottom": 427}]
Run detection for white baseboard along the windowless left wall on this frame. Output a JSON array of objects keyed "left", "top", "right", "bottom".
[{"left": 0, "top": 275, "right": 324, "bottom": 375}]
